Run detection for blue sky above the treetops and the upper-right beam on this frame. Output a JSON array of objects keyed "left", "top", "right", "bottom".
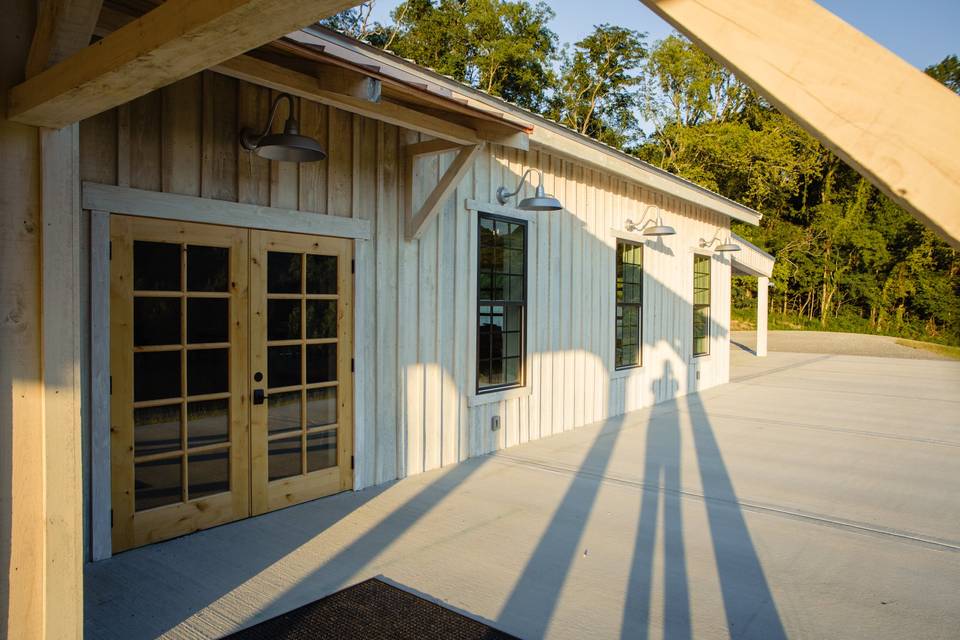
[{"left": 366, "top": 0, "right": 960, "bottom": 68}]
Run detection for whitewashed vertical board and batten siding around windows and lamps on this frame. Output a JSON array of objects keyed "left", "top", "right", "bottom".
[{"left": 80, "top": 72, "right": 730, "bottom": 498}]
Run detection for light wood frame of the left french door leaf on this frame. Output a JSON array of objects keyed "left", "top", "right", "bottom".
[{"left": 110, "top": 215, "right": 250, "bottom": 552}]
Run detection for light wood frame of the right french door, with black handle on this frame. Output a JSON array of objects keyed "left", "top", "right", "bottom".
[{"left": 249, "top": 231, "right": 354, "bottom": 515}]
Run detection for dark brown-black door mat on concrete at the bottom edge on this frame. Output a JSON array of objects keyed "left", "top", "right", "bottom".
[{"left": 229, "top": 578, "right": 516, "bottom": 640}]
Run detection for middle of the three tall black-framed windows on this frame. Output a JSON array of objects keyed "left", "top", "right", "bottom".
[{"left": 614, "top": 239, "right": 643, "bottom": 369}]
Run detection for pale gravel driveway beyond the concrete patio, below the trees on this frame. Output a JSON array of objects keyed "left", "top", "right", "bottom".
[{"left": 730, "top": 331, "right": 950, "bottom": 360}]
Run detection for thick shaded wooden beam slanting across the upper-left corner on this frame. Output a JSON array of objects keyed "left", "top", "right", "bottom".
[{"left": 7, "top": 0, "right": 356, "bottom": 128}]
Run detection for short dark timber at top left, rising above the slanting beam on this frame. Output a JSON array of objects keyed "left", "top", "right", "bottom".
[{"left": 26, "top": 0, "right": 103, "bottom": 78}]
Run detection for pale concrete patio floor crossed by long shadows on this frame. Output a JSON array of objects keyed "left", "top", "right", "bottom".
[{"left": 85, "top": 352, "right": 960, "bottom": 640}]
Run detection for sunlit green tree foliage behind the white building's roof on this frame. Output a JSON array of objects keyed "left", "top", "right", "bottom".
[{"left": 329, "top": 0, "right": 960, "bottom": 344}]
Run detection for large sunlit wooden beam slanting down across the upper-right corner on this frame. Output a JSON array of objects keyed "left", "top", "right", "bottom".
[{"left": 642, "top": 0, "right": 960, "bottom": 247}]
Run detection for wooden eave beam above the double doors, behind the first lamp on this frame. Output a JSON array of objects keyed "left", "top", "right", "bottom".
[{"left": 213, "top": 55, "right": 480, "bottom": 145}]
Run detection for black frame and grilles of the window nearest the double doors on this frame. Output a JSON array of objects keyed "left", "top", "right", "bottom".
[{"left": 474, "top": 211, "right": 530, "bottom": 395}]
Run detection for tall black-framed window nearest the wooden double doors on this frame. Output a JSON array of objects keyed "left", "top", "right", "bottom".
[{"left": 477, "top": 213, "right": 527, "bottom": 392}]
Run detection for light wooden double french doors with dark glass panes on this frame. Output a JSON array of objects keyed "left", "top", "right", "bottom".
[{"left": 110, "top": 215, "right": 353, "bottom": 552}]
